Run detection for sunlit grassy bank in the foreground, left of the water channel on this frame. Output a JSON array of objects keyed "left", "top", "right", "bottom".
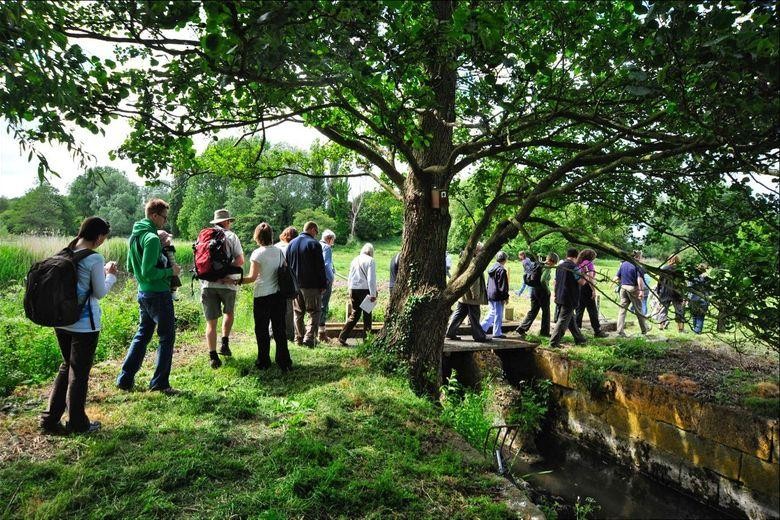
[{"left": 0, "top": 336, "right": 509, "bottom": 518}]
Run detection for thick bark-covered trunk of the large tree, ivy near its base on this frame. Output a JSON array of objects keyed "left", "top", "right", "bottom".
[{"left": 380, "top": 0, "right": 457, "bottom": 395}]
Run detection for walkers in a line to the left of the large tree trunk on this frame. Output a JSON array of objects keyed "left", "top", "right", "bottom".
[{"left": 40, "top": 199, "right": 377, "bottom": 434}]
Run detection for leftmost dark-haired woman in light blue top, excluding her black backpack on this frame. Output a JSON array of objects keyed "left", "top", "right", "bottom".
[{"left": 40, "top": 217, "right": 117, "bottom": 434}]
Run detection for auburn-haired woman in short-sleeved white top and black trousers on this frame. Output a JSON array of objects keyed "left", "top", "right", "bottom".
[{"left": 236, "top": 222, "right": 292, "bottom": 372}]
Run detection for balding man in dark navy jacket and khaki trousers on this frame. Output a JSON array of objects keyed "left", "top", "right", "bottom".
[{"left": 286, "top": 222, "right": 328, "bottom": 348}]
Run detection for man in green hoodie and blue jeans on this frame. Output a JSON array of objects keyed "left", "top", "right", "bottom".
[{"left": 116, "top": 199, "right": 181, "bottom": 395}]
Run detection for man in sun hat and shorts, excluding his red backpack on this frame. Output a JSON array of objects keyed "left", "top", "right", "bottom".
[{"left": 200, "top": 209, "right": 244, "bottom": 368}]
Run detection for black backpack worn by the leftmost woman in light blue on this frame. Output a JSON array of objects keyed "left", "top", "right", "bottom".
[{"left": 24, "top": 247, "right": 95, "bottom": 330}]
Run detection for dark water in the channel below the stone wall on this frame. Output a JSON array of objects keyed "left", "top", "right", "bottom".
[{"left": 511, "top": 436, "right": 733, "bottom": 519}]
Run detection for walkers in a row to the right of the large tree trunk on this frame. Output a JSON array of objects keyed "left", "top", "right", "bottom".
[{"left": 444, "top": 244, "right": 708, "bottom": 347}]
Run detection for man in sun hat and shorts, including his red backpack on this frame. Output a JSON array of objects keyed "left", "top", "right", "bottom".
[{"left": 193, "top": 209, "right": 244, "bottom": 368}]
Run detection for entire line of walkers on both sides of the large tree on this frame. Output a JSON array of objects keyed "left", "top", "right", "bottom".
[{"left": 40, "top": 199, "right": 707, "bottom": 433}]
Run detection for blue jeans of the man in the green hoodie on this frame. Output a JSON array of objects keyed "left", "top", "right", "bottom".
[{"left": 116, "top": 291, "right": 176, "bottom": 390}]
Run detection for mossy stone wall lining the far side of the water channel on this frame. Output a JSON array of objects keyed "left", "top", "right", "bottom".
[{"left": 529, "top": 348, "right": 780, "bottom": 519}]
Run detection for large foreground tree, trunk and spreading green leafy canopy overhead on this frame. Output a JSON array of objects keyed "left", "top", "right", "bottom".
[{"left": 0, "top": 0, "right": 780, "bottom": 390}]
